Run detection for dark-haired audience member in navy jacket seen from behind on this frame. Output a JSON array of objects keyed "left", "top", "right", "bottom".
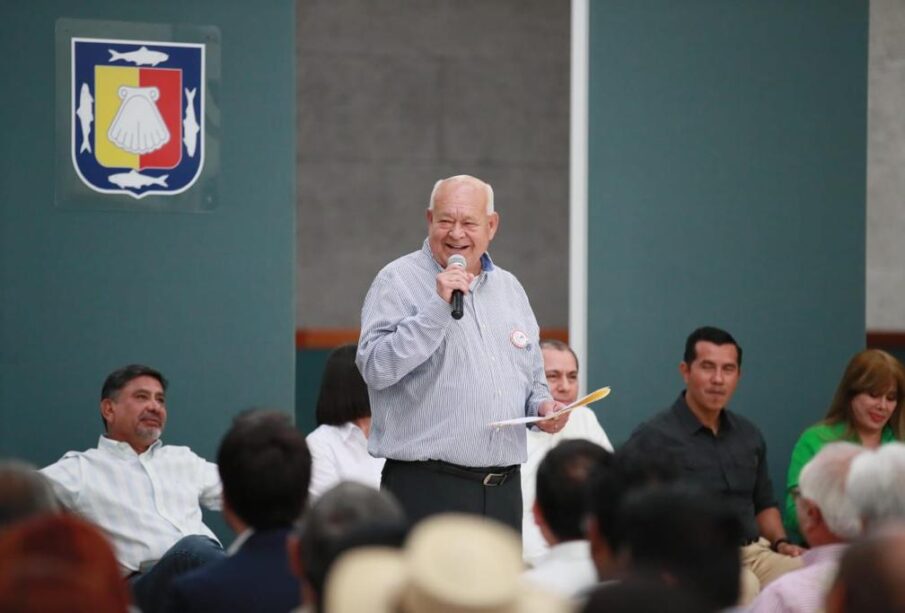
[{"left": 168, "top": 411, "right": 311, "bottom": 613}]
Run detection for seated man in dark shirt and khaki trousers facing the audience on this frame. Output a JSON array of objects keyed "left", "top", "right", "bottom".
[{"left": 626, "top": 327, "right": 803, "bottom": 600}]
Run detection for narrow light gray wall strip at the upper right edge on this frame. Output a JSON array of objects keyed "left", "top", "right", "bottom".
[{"left": 867, "top": 0, "right": 905, "bottom": 331}]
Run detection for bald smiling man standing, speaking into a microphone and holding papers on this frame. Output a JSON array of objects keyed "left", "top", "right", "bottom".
[{"left": 356, "top": 175, "right": 568, "bottom": 531}]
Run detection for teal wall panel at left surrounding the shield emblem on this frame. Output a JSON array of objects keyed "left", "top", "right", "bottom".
[{"left": 0, "top": 0, "right": 296, "bottom": 478}]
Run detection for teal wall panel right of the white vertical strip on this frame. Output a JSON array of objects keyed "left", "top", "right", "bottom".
[{"left": 588, "top": 0, "right": 868, "bottom": 494}]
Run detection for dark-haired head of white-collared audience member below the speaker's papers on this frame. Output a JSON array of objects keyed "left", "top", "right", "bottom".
[{"left": 534, "top": 439, "right": 612, "bottom": 545}]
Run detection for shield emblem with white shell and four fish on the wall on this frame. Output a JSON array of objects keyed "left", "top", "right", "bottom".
[{"left": 70, "top": 38, "right": 205, "bottom": 198}]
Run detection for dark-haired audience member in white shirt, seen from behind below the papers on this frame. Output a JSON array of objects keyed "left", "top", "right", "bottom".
[{"left": 525, "top": 440, "right": 610, "bottom": 598}]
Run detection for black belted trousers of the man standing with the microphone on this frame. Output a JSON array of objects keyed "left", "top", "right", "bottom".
[{"left": 380, "top": 460, "right": 522, "bottom": 533}]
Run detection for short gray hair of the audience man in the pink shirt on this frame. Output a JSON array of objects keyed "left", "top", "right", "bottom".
[{"left": 798, "top": 442, "right": 864, "bottom": 539}]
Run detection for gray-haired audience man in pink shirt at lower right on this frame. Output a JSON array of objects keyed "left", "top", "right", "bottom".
[{"left": 751, "top": 442, "right": 864, "bottom": 613}]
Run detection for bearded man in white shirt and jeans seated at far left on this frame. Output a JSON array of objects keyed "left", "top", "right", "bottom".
[{"left": 41, "top": 364, "right": 223, "bottom": 613}]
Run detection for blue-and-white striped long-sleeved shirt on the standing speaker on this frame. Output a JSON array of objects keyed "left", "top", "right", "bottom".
[{"left": 356, "top": 240, "right": 550, "bottom": 466}]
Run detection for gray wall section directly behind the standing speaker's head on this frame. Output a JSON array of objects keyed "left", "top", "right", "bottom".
[{"left": 296, "top": 0, "right": 570, "bottom": 328}]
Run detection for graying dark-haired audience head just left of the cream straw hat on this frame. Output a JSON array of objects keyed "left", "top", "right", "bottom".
[{"left": 289, "top": 482, "right": 408, "bottom": 610}]
